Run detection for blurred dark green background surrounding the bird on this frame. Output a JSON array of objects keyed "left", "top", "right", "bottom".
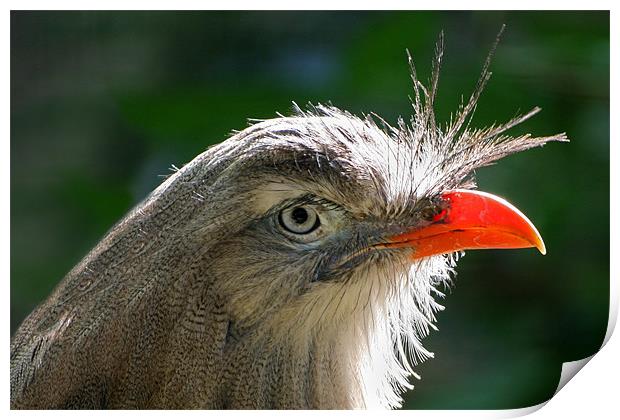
[{"left": 11, "top": 11, "right": 609, "bottom": 409}]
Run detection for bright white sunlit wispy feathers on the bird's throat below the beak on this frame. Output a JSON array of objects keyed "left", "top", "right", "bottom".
[{"left": 358, "top": 256, "right": 453, "bottom": 408}]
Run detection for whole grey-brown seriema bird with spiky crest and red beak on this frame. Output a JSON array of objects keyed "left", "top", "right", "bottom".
[{"left": 11, "top": 36, "right": 566, "bottom": 408}]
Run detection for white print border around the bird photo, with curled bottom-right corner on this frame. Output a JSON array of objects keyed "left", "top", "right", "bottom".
[{"left": 0, "top": 0, "right": 620, "bottom": 420}]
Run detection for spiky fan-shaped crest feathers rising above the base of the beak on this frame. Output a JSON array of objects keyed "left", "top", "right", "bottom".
[{"left": 399, "top": 25, "right": 568, "bottom": 197}]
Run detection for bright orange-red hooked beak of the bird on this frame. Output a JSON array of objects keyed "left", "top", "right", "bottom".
[{"left": 384, "top": 190, "right": 546, "bottom": 259}]
